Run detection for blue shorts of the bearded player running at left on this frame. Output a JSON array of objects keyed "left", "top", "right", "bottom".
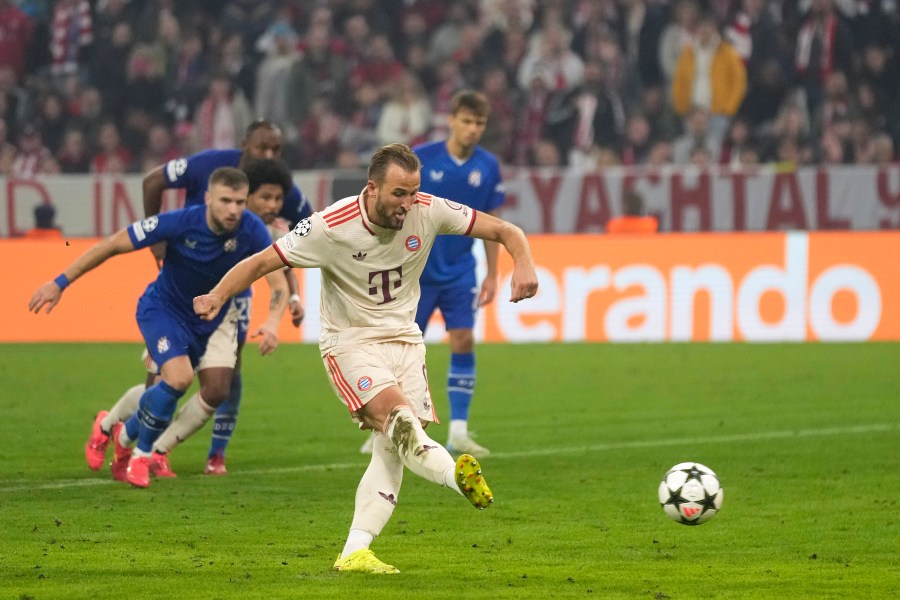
[{"left": 137, "top": 296, "right": 209, "bottom": 368}]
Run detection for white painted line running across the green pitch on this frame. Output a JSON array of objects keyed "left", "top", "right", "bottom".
[{"left": 0, "top": 423, "right": 900, "bottom": 493}]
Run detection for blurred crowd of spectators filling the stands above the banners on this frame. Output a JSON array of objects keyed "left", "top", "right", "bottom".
[{"left": 0, "top": 0, "right": 900, "bottom": 177}]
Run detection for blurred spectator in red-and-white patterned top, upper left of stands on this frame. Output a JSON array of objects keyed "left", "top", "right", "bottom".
[{"left": 50, "top": 0, "right": 94, "bottom": 77}]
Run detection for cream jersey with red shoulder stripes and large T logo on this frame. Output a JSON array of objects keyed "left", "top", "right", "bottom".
[{"left": 274, "top": 191, "right": 477, "bottom": 355}]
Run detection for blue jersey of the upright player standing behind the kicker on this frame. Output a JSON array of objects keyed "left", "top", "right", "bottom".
[{"left": 413, "top": 141, "right": 505, "bottom": 285}]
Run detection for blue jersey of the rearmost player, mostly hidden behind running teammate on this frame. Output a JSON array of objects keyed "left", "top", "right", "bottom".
[{"left": 163, "top": 150, "right": 312, "bottom": 228}]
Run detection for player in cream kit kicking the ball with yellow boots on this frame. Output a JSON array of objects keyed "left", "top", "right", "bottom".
[{"left": 194, "top": 144, "right": 538, "bottom": 574}]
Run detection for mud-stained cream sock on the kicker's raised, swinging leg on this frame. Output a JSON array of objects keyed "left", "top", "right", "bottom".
[{"left": 386, "top": 406, "right": 462, "bottom": 494}]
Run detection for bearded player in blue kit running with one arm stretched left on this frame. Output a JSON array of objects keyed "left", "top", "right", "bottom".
[{"left": 28, "top": 167, "right": 287, "bottom": 487}]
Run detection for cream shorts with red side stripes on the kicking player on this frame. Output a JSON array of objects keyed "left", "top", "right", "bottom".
[{"left": 322, "top": 342, "right": 439, "bottom": 423}]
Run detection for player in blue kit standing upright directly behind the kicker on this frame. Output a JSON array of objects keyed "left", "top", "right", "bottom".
[{"left": 392, "top": 90, "right": 505, "bottom": 456}]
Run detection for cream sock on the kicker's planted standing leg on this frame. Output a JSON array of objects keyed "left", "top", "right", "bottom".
[{"left": 341, "top": 433, "right": 403, "bottom": 558}]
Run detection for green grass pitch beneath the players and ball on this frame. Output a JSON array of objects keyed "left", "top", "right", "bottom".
[{"left": 0, "top": 343, "right": 900, "bottom": 600}]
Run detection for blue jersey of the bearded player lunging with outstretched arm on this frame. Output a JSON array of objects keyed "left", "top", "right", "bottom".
[{"left": 128, "top": 206, "right": 272, "bottom": 334}]
